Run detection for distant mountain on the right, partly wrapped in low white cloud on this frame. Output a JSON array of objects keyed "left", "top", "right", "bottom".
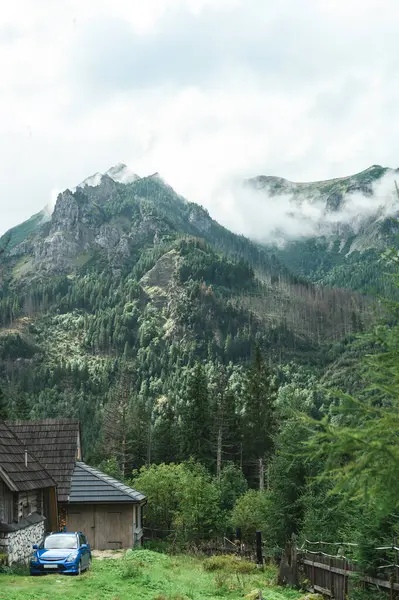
[{"left": 245, "top": 165, "right": 399, "bottom": 295}]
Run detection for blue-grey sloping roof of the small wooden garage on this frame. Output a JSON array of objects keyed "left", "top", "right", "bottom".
[{"left": 69, "top": 462, "right": 146, "bottom": 503}]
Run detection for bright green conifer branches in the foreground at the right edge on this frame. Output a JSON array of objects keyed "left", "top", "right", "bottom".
[{"left": 309, "top": 318, "right": 399, "bottom": 515}]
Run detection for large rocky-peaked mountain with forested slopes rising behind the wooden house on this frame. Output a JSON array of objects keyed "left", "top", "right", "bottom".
[{"left": 0, "top": 161, "right": 376, "bottom": 466}]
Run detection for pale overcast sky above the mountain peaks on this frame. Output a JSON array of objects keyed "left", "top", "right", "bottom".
[{"left": 0, "top": 0, "right": 399, "bottom": 232}]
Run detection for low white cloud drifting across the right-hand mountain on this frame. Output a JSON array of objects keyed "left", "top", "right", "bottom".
[{"left": 214, "top": 172, "right": 399, "bottom": 244}]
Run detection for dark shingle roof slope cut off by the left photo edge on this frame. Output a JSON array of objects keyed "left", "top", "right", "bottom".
[{"left": 0, "top": 421, "right": 56, "bottom": 492}]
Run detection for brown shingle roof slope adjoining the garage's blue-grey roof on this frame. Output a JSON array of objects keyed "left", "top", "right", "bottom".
[{"left": 7, "top": 419, "right": 80, "bottom": 502}]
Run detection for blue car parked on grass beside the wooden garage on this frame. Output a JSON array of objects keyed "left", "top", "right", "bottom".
[{"left": 29, "top": 531, "right": 91, "bottom": 575}]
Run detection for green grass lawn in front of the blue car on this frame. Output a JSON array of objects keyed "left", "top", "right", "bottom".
[{"left": 0, "top": 549, "right": 300, "bottom": 600}]
